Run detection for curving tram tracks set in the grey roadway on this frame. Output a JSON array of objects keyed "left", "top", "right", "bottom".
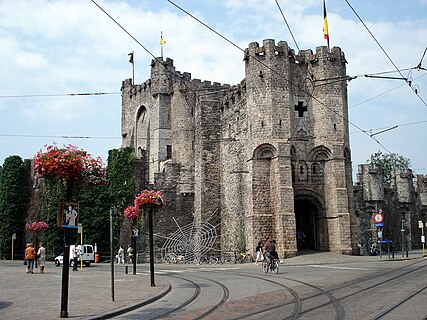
[{"left": 118, "top": 260, "right": 427, "bottom": 320}]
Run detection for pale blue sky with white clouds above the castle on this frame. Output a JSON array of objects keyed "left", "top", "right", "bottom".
[{"left": 0, "top": 0, "right": 427, "bottom": 180}]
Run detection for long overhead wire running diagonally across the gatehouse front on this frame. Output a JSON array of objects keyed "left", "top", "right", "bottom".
[{"left": 165, "top": 0, "right": 392, "bottom": 153}]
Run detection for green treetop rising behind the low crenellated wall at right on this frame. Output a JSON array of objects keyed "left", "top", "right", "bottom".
[{"left": 367, "top": 151, "right": 411, "bottom": 185}]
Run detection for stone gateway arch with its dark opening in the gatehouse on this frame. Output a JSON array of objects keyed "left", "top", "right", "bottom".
[{"left": 294, "top": 189, "right": 329, "bottom": 251}]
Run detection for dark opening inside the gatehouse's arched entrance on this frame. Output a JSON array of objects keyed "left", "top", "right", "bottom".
[{"left": 294, "top": 198, "right": 320, "bottom": 250}]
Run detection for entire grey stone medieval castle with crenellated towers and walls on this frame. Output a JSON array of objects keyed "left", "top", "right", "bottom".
[{"left": 121, "top": 40, "right": 427, "bottom": 257}]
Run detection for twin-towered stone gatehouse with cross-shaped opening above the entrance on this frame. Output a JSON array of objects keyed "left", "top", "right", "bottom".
[{"left": 234, "top": 40, "right": 353, "bottom": 256}]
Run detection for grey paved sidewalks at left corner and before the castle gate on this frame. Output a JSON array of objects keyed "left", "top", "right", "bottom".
[{"left": 0, "top": 250, "right": 423, "bottom": 319}]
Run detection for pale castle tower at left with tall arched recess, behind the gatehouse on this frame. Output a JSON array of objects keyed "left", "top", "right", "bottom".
[{"left": 122, "top": 58, "right": 175, "bottom": 183}]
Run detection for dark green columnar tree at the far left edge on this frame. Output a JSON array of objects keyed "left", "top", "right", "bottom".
[{"left": 0, "top": 156, "right": 31, "bottom": 258}]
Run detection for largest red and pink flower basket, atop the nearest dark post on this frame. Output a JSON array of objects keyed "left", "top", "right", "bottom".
[{"left": 34, "top": 144, "right": 107, "bottom": 185}]
